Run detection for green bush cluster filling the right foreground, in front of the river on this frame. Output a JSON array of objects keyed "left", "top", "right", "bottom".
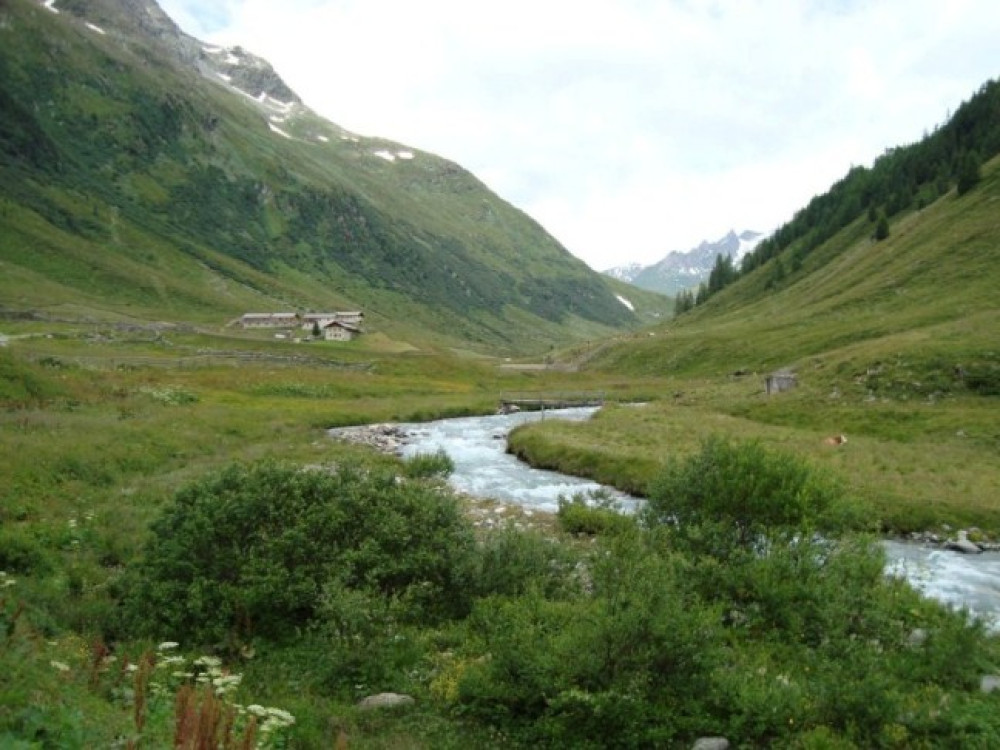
[{"left": 448, "top": 440, "right": 1000, "bottom": 748}]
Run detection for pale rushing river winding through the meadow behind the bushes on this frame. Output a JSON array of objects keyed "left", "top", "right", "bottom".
[{"left": 400, "top": 407, "right": 1000, "bottom": 632}]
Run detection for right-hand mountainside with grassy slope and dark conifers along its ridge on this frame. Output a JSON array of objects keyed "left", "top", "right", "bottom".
[{"left": 589, "top": 103, "right": 1000, "bottom": 384}]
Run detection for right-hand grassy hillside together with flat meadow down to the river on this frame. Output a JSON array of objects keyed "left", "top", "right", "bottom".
[{"left": 511, "top": 111, "right": 1000, "bottom": 532}]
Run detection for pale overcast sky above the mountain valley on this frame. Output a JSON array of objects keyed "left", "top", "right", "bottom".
[{"left": 160, "top": 0, "right": 1000, "bottom": 270}]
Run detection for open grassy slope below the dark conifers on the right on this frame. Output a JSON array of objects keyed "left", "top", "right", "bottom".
[{"left": 602, "top": 155, "right": 1000, "bottom": 382}]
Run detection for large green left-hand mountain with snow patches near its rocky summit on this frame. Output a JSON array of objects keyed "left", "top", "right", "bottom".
[{"left": 0, "top": 0, "right": 663, "bottom": 351}]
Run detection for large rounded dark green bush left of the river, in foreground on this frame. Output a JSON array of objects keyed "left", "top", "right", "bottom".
[{"left": 126, "top": 463, "right": 474, "bottom": 644}]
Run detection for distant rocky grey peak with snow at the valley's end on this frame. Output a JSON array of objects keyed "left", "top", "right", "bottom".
[{"left": 604, "top": 230, "right": 764, "bottom": 295}]
